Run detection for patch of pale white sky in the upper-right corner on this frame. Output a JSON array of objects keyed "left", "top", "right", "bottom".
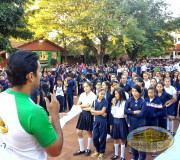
[{"left": 164, "top": 0, "right": 180, "bottom": 17}]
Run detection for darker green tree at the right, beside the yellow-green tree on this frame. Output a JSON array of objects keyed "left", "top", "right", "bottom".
[{"left": 121, "top": 0, "right": 176, "bottom": 60}]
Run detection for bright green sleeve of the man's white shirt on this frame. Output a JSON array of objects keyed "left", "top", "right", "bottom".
[{"left": 16, "top": 98, "right": 58, "bottom": 148}]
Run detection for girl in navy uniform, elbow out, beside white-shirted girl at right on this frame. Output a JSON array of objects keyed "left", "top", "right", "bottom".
[{"left": 156, "top": 82, "right": 173, "bottom": 129}]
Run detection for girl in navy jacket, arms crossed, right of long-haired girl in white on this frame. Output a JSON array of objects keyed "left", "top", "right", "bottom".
[{"left": 124, "top": 84, "right": 146, "bottom": 160}]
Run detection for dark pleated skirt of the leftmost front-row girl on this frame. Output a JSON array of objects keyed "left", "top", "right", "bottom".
[{"left": 76, "top": 111, "right": 94, "bottom": 131}]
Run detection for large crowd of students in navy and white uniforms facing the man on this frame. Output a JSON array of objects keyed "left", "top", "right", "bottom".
[{"left": 0, "top": 61, "right": 180, "bottom": 160}]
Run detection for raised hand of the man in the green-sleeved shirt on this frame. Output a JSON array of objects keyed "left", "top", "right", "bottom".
[{"left": 45, "top": 94, "right": 60, "bottom": 115}]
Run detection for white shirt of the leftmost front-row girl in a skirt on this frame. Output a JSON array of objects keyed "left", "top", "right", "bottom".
[{"left": 79, "top": 91, "right": 97, "bottom": 105}]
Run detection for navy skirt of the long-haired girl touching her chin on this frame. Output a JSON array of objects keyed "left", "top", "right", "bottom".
[{"left": 112, "top": 118, "right": 129, "bottom": 141}]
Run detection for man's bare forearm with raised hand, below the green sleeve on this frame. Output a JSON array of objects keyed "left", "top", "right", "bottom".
[{"left": 44, "top": 94, "right": 63, "bottom": 157}]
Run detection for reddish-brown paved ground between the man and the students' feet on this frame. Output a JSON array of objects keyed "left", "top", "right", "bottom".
[{"left": 47, "top": 99, "right": 179, "bottom": 160}]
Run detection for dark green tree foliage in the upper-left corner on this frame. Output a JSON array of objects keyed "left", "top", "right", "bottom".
[{"left": 0, "top": 0, "right": 32, "bottom": 52}]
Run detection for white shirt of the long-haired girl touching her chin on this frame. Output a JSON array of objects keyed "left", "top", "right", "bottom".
[{"left": 111, "top": 101, "right": 126, "bottom": 118}]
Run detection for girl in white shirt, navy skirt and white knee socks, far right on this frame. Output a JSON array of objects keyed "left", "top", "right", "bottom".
[{"left": 164, "top": 78, "right": 177, "bottom": 135}]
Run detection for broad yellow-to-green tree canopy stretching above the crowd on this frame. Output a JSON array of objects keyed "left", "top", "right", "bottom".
[{"left": 26, "top": 0, "right": 177, "bottom": 64}]
